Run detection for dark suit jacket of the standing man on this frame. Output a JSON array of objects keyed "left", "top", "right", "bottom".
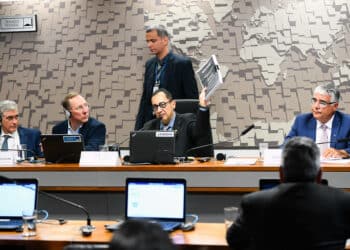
[{"left": 135, "top": 52, "right": 199, "bottom": 130}]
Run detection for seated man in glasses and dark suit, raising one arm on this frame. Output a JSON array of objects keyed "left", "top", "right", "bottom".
[{"left": 142, "top": 88, "right": 214, "bottom": 156}]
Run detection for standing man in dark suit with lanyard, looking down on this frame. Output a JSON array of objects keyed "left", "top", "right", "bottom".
[{"left": 135, "top": 26, "right": 198, "bottom": 130}]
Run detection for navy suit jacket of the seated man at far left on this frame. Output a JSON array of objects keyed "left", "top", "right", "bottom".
[{"left": 0, "top": 126, "right": 44, "bottom": 157}]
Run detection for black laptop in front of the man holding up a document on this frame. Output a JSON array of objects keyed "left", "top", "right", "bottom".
[{"left": 129, "top": 130, "right": 176, "bottom": 164}]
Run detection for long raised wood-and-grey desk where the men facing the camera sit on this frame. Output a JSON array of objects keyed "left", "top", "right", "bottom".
[{"left": 0, "top": 160, "right": 350, "bottom": 193}]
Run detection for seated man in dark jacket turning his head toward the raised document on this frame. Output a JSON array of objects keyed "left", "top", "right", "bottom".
[{"left": 52, "top": 92, "right": 106, "bottom": 151}]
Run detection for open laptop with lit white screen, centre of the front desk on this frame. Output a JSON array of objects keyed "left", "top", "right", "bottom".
[{"left": 125, "top": 178, "right": 186, "bottom": 232}]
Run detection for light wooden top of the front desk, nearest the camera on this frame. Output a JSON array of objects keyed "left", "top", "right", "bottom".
[{"left": 0, "top": 221, "right": 228, "bottom": 250}]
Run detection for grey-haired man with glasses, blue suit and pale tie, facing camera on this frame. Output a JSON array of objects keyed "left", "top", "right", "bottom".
[{"left": 285, "top": 85, "right": 350, "bottom": 158}]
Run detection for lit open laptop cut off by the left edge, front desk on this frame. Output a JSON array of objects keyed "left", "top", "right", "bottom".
[{"left": 0, "top": 179, "right": 38, "bottom": 230}]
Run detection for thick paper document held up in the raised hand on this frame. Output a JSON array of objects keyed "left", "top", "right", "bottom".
[{"left": 197, "top": 55, "right": 223, "bottom": 99}]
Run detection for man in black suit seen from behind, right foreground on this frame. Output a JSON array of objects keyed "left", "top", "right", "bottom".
[{"left": 226, "top": 137, "right": 350, "bottom": 250}]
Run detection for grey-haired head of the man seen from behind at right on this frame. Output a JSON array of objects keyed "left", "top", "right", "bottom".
[{"left": 281, "top": 136, "right": 320, "bottom": 182}]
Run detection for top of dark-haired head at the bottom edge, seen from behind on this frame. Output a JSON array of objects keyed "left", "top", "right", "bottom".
[{"left": 110, "top": 220, "right": 176, "bottom": 250}]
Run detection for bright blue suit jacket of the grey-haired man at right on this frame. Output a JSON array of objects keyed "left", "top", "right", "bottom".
[{"left": 284, "top": 111, "right": 350, "bottom": 153}]
